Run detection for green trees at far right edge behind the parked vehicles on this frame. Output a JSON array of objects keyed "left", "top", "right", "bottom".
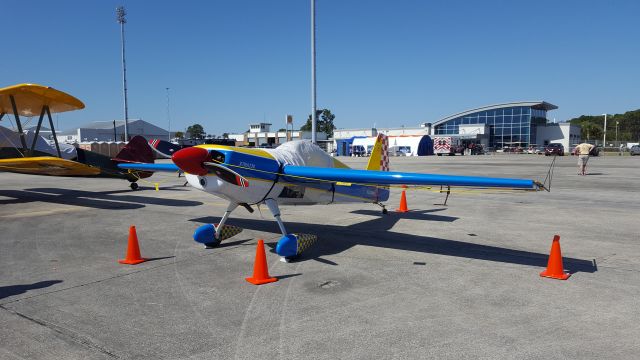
[{"left": 569, "top": 109, "right": 640, "bottom": 142}]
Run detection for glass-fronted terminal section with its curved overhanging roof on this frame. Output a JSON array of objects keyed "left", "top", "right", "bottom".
[{"left": 433, "top": 101, "right": 558, "bottom": 148}]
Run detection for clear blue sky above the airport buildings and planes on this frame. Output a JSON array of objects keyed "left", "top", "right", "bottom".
[{"left": 0, "top": 0, "right": 640, "bottom": 135}]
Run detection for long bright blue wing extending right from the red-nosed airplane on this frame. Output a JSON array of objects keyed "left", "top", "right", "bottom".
[{"left": 282, "top": 165, "right": 542, "bottom": 190}]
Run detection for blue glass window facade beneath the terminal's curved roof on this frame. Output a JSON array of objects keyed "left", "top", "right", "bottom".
[{"left": 434, "top": 106, "right": 547, "bottom": 149}]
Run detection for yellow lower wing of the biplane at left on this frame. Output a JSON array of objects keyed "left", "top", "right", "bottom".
[{"left": 0, "top": 156, "right": 101, "bottom": 176}]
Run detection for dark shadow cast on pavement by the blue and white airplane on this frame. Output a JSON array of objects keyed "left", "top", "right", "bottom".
[{"left": 190, "top": 208, "right": 598, "bottom": 273}]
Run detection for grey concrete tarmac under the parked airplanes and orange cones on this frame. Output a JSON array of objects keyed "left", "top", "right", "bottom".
[{"left": 0, "top": 155, "right": 640, "bottom": 359}]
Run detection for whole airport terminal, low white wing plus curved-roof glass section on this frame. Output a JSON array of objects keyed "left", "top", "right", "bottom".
[{"left": 334, "top": 101, "right": 581, "bottom": 156}]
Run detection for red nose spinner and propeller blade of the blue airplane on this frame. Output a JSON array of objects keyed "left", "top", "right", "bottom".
[{"left": 171, "top": 147, "right": 249, "bottom": 187}]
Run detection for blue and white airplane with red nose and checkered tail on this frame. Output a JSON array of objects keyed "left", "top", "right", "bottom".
[{"left": 118, "top": 135, "right": 544, "bottom": 261}]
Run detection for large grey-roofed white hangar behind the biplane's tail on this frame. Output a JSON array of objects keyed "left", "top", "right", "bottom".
[{"left": 56, "top": 119, "right": 169, "bottom": 144}]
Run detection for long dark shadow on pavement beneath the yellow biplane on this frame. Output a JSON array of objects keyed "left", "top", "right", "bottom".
[{"left": 0, "top": 188, "right": 202, "bottom": 210}]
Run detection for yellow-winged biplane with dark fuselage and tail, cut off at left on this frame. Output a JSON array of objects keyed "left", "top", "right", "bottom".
[{"left": 0, "top": 84, "right": 154, "bottom": 190}]
